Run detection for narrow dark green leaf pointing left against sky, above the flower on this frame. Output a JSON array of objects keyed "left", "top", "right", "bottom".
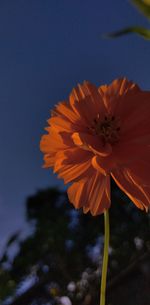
[{"left": 104, "top": 26, "right": 150, "bottom": 40}]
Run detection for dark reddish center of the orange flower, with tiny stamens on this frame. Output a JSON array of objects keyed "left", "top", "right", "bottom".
[{"left": 91, "top": 115, "right": 120, "bottom": 145}]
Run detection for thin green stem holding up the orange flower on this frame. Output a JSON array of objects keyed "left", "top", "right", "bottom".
[{"left": 100, "top": 210, "right": 109, "bottom": 305}]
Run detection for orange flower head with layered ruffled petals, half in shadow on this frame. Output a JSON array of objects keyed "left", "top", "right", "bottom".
[{"left": 40, "top": 78, "right": 150, "bottom": 215}]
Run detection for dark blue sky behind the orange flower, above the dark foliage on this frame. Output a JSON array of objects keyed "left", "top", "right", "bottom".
[{"left": 0, "top": 0, "right": 150, "bottom": 245}]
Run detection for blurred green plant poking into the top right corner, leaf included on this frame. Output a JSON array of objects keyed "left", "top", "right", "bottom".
[{"left": 105, "top": 0, "right": 150, "bottom": 40}]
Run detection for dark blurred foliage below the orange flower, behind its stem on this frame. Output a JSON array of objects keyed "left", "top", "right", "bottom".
[{"left": 0, "top": 183, "right": 150, "bottom": 305}]
